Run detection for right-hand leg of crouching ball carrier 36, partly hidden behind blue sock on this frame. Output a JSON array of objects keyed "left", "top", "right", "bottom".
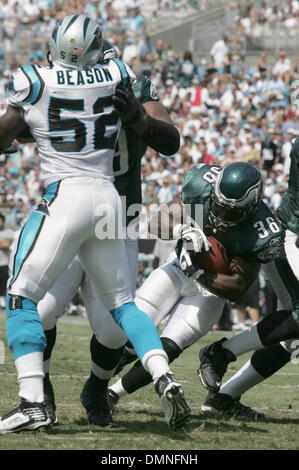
[{"left": 109, "top": 292, "right": 225, "bottom": 403}]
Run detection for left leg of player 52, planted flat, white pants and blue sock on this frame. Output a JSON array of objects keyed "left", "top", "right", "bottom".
[{"left": 0, "top": 183, "right": 87, "bottom": 433}]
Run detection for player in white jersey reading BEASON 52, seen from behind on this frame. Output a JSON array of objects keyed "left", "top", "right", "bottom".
[{"left": 0, "top": 15, "right": 190, "bottom": 433}]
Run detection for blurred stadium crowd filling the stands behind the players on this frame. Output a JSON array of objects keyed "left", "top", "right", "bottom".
[{"left": 0, "top": 0, "right": 299, "bottom": 326}]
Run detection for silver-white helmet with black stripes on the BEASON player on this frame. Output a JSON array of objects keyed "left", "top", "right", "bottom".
[{"left": 49, "top": 15, "right": 103, "bottom": 69}]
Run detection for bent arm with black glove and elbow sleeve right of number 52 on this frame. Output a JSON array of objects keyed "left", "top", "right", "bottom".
[{"left": 113, "top": 85, "right": 180, "bottom": 155}]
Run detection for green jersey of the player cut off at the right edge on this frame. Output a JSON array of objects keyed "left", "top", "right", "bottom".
[{"left": 276, "top": 138, "right": 299, "bottom": 234}]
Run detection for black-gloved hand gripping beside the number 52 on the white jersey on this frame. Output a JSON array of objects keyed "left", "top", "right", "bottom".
[{"left": 112, "top": 85, "right": 146, "bottom": 124}]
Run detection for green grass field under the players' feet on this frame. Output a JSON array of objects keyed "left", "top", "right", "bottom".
[{"left": 0, "top": 315, "right": 299, "bottom": 451}]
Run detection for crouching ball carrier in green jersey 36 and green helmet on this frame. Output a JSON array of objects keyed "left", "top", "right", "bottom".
[{"left": 109, "top": 162, "right": 290, "bottom": 408}]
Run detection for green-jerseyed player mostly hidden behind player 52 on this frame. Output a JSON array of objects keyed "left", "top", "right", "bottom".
[{"left": 38, "top": 44, "right": 184, "bottom": 426}]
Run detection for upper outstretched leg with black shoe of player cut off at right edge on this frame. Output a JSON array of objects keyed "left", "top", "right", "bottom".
[{"left": 199, "top": 232, "right": 299, "bottom": 392}]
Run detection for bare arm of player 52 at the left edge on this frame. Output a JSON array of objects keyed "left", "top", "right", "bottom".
[{"left": 0, "top": 105, "right": 26, "bottom": 150}]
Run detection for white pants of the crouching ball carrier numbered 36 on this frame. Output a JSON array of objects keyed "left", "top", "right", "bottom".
[{"left": 135, "top": 252, "right": 226, "bottom": 350}]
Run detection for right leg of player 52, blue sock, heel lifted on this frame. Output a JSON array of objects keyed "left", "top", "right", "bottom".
[{"left": 80, "top": 238, "right": 190, "bottom": 429}]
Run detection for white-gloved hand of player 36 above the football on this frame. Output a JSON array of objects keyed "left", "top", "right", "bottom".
[{"left": 173, "top": 224, "right": 211, "bottom": 253}]
